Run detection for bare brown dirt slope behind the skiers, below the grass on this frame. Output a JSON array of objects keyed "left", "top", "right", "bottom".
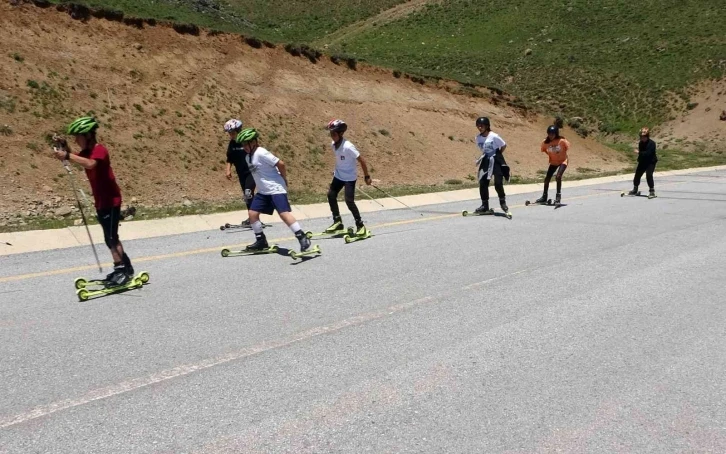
[{"left": 0, "top": 2, "right": 622, "bottom": 221}]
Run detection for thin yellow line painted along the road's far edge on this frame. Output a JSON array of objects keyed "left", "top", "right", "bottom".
[{"left": 0, "top": 182, "right": 683, "bottom": 283}]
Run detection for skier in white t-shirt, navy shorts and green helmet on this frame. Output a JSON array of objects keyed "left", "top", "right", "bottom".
[{"left": 237, "top": 128, "right": 310, "bottom": 252}]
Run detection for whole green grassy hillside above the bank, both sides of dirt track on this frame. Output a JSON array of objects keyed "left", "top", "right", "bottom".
[{"left": 48, "top": 0, "right": 726, "bottom": 132}]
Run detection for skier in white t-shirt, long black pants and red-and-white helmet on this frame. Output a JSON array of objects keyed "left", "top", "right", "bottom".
[{"left": 325, "top": 120, "right": 371, "bottom": 236}]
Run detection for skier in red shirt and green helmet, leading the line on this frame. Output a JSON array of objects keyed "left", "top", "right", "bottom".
[{"left": 54, "top": 117, "right": 134, "bottom": 285}]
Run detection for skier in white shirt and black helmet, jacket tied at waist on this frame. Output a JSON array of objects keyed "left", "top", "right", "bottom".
[{"left": 476, "top": 117, "right": 509, "bottom": 213}]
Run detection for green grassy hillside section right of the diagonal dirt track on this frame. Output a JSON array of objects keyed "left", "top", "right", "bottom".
[{"left": 338, "top": 0, "right": 726, "bottom": 132}]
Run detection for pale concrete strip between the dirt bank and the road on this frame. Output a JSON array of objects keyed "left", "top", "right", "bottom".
[{"left": 0, "top": 166, "right": 726, "bottom": 256}]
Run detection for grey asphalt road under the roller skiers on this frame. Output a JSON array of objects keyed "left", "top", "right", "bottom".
[{"left": 0, "top": 171, "right": 726, "bottom": 453}]
